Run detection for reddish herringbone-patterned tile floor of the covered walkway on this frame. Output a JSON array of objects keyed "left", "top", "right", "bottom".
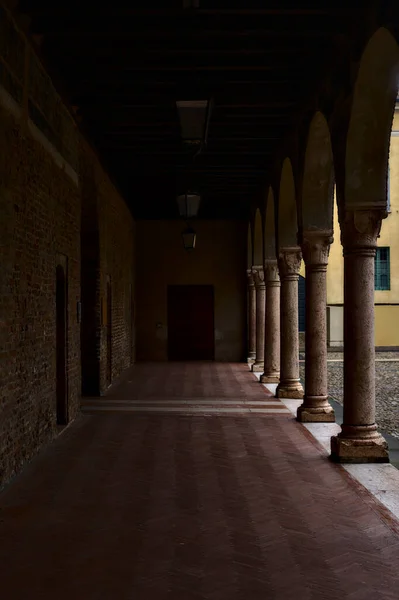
[{"left": 0, "top": 364, "right": 399, "bottom": 600}]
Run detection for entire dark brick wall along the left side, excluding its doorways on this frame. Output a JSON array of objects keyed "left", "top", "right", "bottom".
[{"left": 0, "top": 9, "right": 134, "bottom": 486}]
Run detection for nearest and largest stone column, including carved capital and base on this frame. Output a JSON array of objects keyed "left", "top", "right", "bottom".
[{"left": 331, "top": 209, "right": 389, "bottom": 463}]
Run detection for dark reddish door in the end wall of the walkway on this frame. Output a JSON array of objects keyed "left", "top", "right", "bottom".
[{"left": 168, "top": 285, "right": 215, "bottom": 360}]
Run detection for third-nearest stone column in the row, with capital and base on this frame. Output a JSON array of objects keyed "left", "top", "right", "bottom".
[{"left": 276, "top": 246, "right": 303, "bottom": 398}]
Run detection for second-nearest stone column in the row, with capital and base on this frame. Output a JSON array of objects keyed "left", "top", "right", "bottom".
[{"left": 297, "top": 231, "right": 335, "bottom": 423}]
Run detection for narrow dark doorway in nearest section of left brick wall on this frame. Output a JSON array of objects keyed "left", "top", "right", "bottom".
[{"left": 56, "top": 265, "right": 68, "bottom": 425}]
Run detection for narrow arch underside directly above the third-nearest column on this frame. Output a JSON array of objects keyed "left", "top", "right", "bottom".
[{"left": 278, "top": 157, "right": 298, "bottom": 248}]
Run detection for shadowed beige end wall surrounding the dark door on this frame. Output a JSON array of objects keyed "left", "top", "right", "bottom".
[{"left": 136, "top": 221, "right": 247, "bottom": 361}]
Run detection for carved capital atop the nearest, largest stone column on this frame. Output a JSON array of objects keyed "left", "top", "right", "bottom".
[{"left": 340, "top": 208, "right": 386, "bottom": 256}]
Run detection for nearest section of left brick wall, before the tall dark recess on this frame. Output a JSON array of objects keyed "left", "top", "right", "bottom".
[{"left": 0, "top": 104, "right": 80, "bottom": 488}]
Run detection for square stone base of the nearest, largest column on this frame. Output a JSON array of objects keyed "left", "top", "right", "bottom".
[{"left": 330, "top": 428, "right": 389, "bottom": 463}]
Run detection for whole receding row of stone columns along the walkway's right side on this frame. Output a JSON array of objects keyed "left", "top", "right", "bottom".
[{"left": 247, "top": 210, "right": 389, "bottom": 462}]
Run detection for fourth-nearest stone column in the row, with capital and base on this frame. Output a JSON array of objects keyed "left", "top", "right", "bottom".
[{"left": 260, "top": 259, "right": 280, "bottom": 383}]
